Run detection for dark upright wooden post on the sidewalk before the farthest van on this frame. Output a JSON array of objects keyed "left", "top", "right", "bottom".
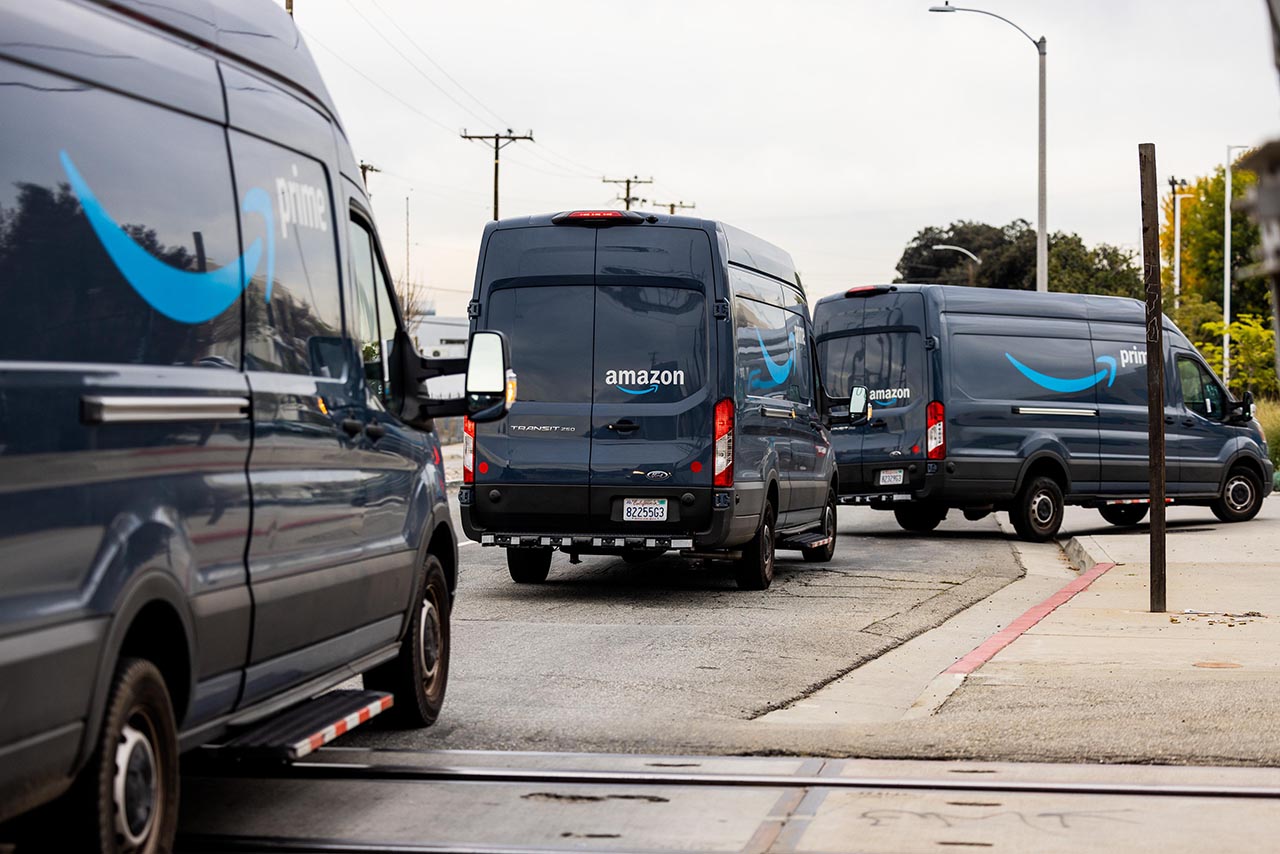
[{"left": 1138, "top": 142, "right": 1165, "bottom": 612}]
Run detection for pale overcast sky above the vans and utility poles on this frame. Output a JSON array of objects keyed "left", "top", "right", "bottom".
[{"left": 280, "top": 0, "right": 1280, "bottom": 315}]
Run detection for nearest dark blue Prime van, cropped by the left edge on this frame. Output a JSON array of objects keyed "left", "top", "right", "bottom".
[{"left": 0, "top": 0, "right": 506, "bottom": 851}]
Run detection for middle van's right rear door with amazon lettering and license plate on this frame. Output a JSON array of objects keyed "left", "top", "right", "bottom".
[{"left": 591, "top": 227, "right": 716, "bottom": 535}]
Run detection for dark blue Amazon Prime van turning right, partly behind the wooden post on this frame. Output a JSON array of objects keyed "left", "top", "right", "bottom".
[{"left": 814, "top": 284, "right": 1274, "bottom": 540}]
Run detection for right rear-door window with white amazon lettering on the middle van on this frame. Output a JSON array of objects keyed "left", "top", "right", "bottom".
[{"left": 593, "top": 286, "right": 707, "bottom": 403}]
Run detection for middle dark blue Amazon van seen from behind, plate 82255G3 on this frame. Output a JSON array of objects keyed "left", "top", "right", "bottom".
[{"left": 460, "top": 210, "right": 838, "bottom": 589}]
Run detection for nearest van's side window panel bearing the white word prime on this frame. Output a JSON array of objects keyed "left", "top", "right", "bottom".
[{"left": 230, "top": 131, "right": 346, "bottom": 380}]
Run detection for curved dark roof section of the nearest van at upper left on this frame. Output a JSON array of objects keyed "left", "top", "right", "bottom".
[{"left": 90, "top": 0, "right": 342, "bottom": 128}]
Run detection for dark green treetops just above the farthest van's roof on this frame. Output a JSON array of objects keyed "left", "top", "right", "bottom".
[{"left": 895, "top": 219, "right": 1142, "bottom": 297}]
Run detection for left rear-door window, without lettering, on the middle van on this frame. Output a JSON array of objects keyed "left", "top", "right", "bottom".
[{"left": 488, "top": 286, "right": 595, "bottom": 403}]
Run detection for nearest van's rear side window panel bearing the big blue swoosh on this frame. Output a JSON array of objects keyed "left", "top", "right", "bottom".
[{"left": 0, "top": 60, "right": 241, "bottom": 370}]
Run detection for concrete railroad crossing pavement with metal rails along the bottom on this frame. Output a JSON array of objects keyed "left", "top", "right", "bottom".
[{"left": 178, "top": 748, "right": 1280, "bottom": 854}]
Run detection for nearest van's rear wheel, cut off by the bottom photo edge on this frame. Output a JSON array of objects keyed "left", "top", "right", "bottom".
[{"left": 59, "top": 658, "right": 178, "bottom": 854}]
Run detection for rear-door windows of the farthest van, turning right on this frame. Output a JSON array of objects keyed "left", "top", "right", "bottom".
[{"left": 818, "top": 330, "right": 924, "bottom": 407}]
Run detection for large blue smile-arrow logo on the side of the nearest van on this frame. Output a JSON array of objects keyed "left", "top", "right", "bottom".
[{"left": 59, "top": 151, "right": 275, "bottom": 324}]
